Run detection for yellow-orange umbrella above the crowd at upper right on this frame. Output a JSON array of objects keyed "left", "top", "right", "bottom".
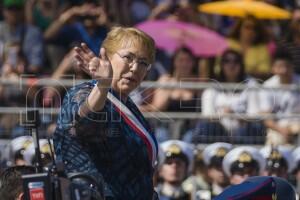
[{"left": 198, "top": 0, "right": 291, "bottom": 19}]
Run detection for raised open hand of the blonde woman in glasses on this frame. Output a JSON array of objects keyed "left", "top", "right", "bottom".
[{"left": 75, "top": 43, "right": 113, "bottom": 86}]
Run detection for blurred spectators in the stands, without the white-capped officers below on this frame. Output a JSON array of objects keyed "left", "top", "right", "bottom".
[{"left": 0, "top": 0, "right": 300, "bottom": 144}]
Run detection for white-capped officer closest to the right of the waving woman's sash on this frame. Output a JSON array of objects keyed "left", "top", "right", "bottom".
[{"left": 157, "top": 140, "right": 193, "bottom": 200}]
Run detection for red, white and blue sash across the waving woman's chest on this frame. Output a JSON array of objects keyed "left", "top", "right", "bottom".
[{"left": 107, "top": 92, "right": 158, "bottom": 167}]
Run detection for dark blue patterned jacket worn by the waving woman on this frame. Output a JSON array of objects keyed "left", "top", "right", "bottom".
[{"left": 54, "top": 81, "right": 157, "bottom": 200}]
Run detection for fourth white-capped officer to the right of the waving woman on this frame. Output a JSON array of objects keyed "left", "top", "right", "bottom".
[{"left": 260, "top": 146, "right": 295, "bottom": 179}]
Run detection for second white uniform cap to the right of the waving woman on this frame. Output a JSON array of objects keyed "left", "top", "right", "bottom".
[{"left": 202, "top": 142, "right": 232, "bottom": 165}]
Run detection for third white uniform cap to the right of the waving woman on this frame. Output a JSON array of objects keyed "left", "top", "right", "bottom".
[{"left": 223, "top": 146, "right": 266, "bottom": 176}]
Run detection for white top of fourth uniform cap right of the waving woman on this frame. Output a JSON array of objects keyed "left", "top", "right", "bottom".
[{"left": 260, "top": 146, "right": 295, "bottom": 172}]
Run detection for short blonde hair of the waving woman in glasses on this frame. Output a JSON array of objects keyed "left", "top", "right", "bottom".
[{"left": 102, "top": 27, "right": 155, "bottom": 63}]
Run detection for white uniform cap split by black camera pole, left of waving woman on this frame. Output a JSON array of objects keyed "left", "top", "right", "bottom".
[{"left": 24, "top": 139, "right": 50, "bottom": 165}]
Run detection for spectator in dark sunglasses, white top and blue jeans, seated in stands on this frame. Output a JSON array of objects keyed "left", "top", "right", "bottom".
[{"left": 184, "top": 50, "right": 263, "bottom": 143}]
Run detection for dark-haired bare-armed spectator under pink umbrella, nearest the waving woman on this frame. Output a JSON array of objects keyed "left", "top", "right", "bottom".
[{"left": 140, "top": 48, "right": 197, "bottom": 112}]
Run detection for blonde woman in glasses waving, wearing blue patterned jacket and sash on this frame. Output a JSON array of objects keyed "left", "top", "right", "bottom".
[{"left": 54, "top": 27, "right": 157, "bottom": 200}]
